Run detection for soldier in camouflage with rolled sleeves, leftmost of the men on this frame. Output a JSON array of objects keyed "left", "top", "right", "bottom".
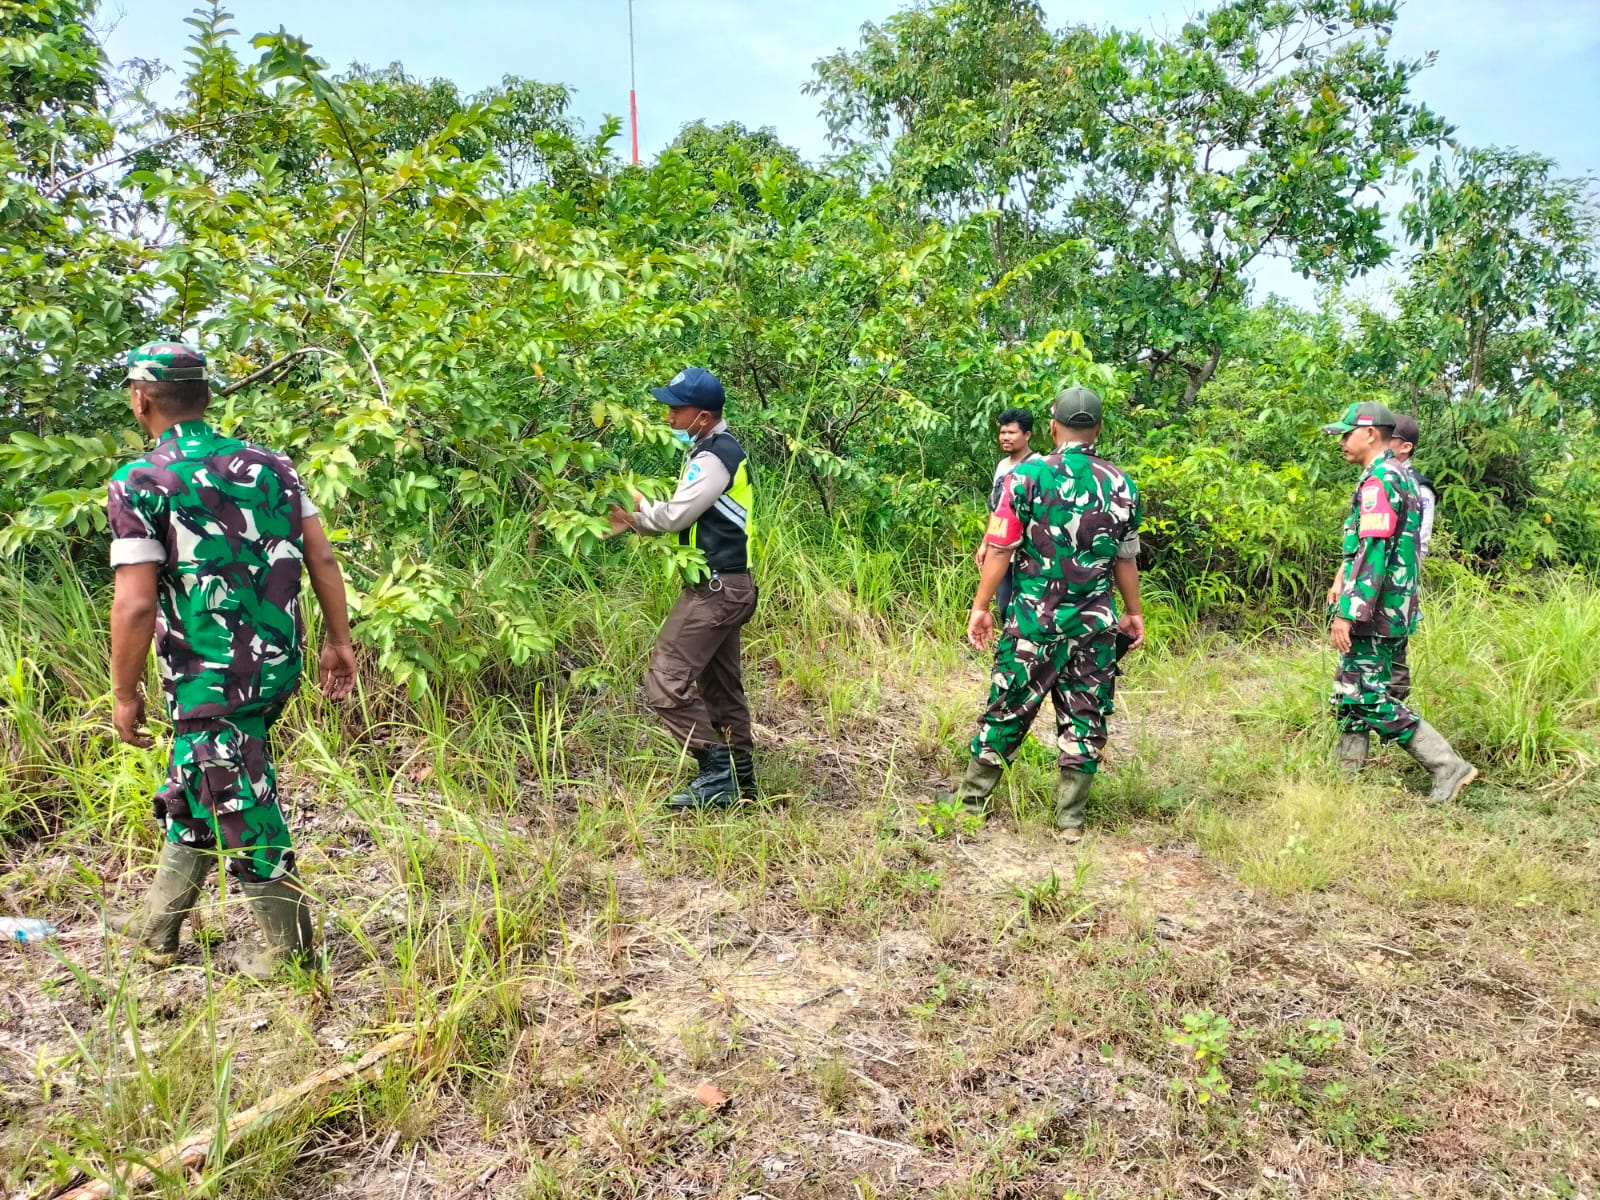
[{"left": 107, "top": 342, "right": 355, "bottom": 976}]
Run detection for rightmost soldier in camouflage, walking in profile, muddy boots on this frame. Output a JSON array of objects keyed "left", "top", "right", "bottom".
[{"left": 1323, "top": 402, "right": 1477, "bottom": 803}]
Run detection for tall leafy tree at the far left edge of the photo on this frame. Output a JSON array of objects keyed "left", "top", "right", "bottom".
[{"left": 0, "top": 0, "right": 154, "bottom": 533}]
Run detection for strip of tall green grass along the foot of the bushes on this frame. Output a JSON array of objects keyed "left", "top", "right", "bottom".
[{"left": 0, "top": 522, "right": 1600, "bottom": 837}]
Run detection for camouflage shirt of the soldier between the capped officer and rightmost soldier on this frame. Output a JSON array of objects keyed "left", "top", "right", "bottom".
[{"left": 987, "top": 445, "right": 1139, "bottom": 642}]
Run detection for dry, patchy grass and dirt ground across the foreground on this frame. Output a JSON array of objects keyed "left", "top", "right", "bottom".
[{"left": 0, "top": 659, "right": 1600, "bottom": 1200}]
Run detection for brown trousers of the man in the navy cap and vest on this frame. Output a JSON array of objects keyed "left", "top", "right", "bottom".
[{"left": 645, "top": 571, "right": 757, "bottom": 750}]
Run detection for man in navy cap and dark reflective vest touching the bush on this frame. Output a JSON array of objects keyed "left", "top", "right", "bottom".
[{"left": 608, "top": 366, "right": 757, "bottom": 810}]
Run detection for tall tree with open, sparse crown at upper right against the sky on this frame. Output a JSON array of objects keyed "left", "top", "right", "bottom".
[{"left": 1072, "top": 0, "right": 1448, "bottom": 408}]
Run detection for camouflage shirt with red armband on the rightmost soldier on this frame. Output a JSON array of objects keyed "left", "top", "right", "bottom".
[{"left": 1338, "top": 450, "right": 1422, "bottom": 637}]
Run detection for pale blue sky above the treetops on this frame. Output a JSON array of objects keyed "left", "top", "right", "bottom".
[{"left": 102, "top": 0, "right": 1600, "bottom": 299}]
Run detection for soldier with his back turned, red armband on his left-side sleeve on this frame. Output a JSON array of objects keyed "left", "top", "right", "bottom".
[{"left": 955, "top": 387, "right": 1144, "bottom": 842}]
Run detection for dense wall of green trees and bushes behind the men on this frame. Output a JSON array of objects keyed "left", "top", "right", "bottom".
[{"left": 0, "top": 0, "right": 1600, "bottom": 668}]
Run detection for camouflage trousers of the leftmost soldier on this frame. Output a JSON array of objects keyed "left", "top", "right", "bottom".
[{"left": 154, "top": 714, "right": 294, "bottom": 883}]
